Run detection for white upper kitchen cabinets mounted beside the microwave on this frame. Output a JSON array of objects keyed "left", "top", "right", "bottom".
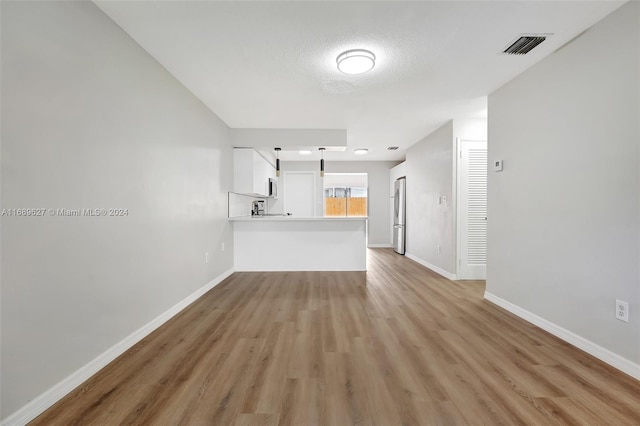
[{"left": 233, "top": 148, "right": 276, "bottom": 197}]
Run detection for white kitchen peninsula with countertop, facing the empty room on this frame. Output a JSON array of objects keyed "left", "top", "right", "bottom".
[{"left": 229, "top": 216, "right": 367, "bottom": 271}]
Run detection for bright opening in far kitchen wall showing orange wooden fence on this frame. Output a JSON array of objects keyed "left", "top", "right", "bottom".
[{"left": 323, "top": 173, "right": 369, "bottom": 217}]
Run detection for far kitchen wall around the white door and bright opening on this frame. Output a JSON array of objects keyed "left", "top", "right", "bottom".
[{"left": 270, "top": 161, "right": 398, "bottom": 246}]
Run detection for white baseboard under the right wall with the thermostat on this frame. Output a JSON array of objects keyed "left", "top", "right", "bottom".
[{"left": 484, "top": 292, "right": 640, "bottom": 380}]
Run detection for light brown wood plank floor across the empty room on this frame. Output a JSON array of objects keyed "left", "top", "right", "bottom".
[{"left": 33, "top": 249, "right": 640, "bottom": 425}]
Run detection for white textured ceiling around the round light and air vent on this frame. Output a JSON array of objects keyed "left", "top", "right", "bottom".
[{"left": 95, "top": 1, "right": 622, "bottom": 160}]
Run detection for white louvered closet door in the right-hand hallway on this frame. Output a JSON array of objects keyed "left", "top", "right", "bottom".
[{"left": 458, "top": 141, "right": 487, "bottom": 279}]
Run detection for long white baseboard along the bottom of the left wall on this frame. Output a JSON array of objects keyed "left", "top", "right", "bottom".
[{"left": 1, "top": 268, "right": 234, "bottom": 426}]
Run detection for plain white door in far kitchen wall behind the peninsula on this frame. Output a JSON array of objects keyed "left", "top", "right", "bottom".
[{"left": 282, "top": 172, "right": 316, "bottom": 217}]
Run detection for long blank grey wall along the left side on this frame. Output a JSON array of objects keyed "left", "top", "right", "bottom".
[{"left": 0, "top": 2, "right": 233, "bottom": 418}]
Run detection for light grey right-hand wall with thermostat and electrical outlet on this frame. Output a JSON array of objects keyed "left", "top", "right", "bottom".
[{"left": 487, "top": 2, "right": 640, "bottom": 371}]
